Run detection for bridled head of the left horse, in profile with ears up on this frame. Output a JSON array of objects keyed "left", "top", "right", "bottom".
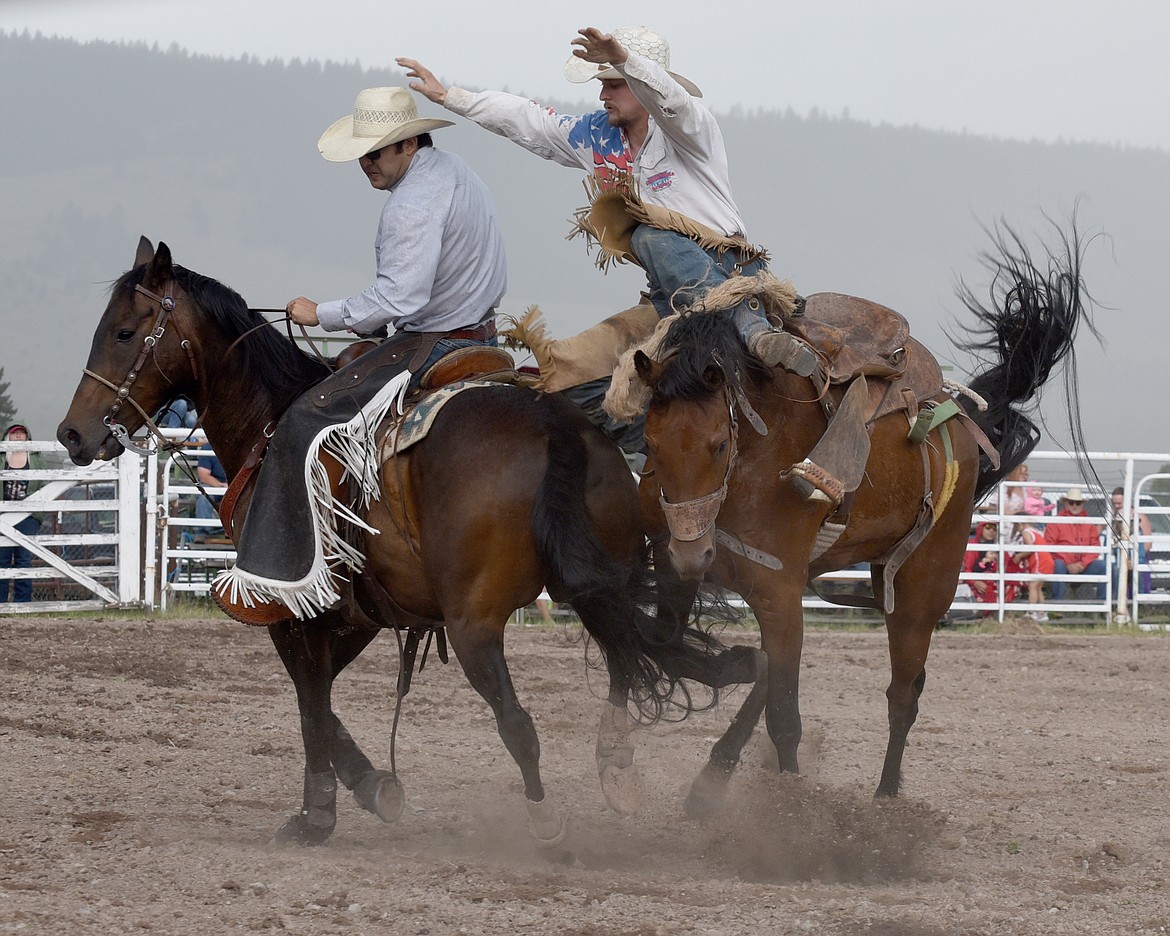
[{"left": 57, "top": 238, "right": 195, "bottom": 464}]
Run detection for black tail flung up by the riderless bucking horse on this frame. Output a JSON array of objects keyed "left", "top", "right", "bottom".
[{"left": 956, "top": 215, "right": 1100, "bottom": 503}]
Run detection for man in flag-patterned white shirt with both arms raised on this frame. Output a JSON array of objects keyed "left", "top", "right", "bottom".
[{"left": 395, "top": 26, "right": 817, "bottom": 423}]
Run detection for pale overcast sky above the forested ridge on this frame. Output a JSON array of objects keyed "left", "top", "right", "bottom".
[{"left": 0, "top": 0, "right": 1170, "bottom": 150}]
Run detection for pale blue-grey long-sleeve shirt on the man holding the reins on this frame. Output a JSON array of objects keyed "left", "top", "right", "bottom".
[{"left": 317, "top": 146, "right": 508, "bottom": 335}]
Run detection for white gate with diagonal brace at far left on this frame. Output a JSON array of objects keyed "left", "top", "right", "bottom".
[{"left": 0, "top": 441, "right": 143, "bottom": 614}]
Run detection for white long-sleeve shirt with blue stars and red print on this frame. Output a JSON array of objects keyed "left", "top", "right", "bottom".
[{"left": 445, "top": 53, "right": 746, "bottom": 238}]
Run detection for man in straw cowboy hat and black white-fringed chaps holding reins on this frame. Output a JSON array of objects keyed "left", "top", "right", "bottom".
[{"left": 215, "top": 88, "right": 507, "bottom": 619}]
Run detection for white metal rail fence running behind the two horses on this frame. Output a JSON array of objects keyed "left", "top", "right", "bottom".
[{"left": 0, "top": 439, "right": 1170, "bottom": 624}]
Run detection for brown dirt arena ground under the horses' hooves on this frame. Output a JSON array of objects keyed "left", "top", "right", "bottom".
[{"left": 0, "top": 618, "right": 1170, "bottom": 936}]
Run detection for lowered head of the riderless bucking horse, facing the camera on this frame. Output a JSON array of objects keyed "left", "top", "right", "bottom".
[{"left": 634, "top": 312, "right": 751, "bottom": 579}]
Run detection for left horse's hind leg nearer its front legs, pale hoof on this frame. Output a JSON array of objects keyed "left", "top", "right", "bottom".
[{"left": 447, "top": 615, "right": 566, "bottom": 848}]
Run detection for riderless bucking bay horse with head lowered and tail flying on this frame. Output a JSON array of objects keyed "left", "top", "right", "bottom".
[{"left": 633, "top": 226, "right": 1095, "bottom": 814}]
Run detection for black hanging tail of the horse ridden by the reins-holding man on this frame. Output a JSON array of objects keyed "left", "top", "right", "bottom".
[{"left": 532, "top": 397, "right": 723, "bottom": 721}]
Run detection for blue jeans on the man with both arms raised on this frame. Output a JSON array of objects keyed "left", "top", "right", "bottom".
[{"left": 629, "top": 225, "right": 769, "bottom": 340}]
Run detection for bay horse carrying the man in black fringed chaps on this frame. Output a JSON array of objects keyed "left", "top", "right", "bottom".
[{"left": 57, "top": 238, "right": 758, "bottom": 848}]
